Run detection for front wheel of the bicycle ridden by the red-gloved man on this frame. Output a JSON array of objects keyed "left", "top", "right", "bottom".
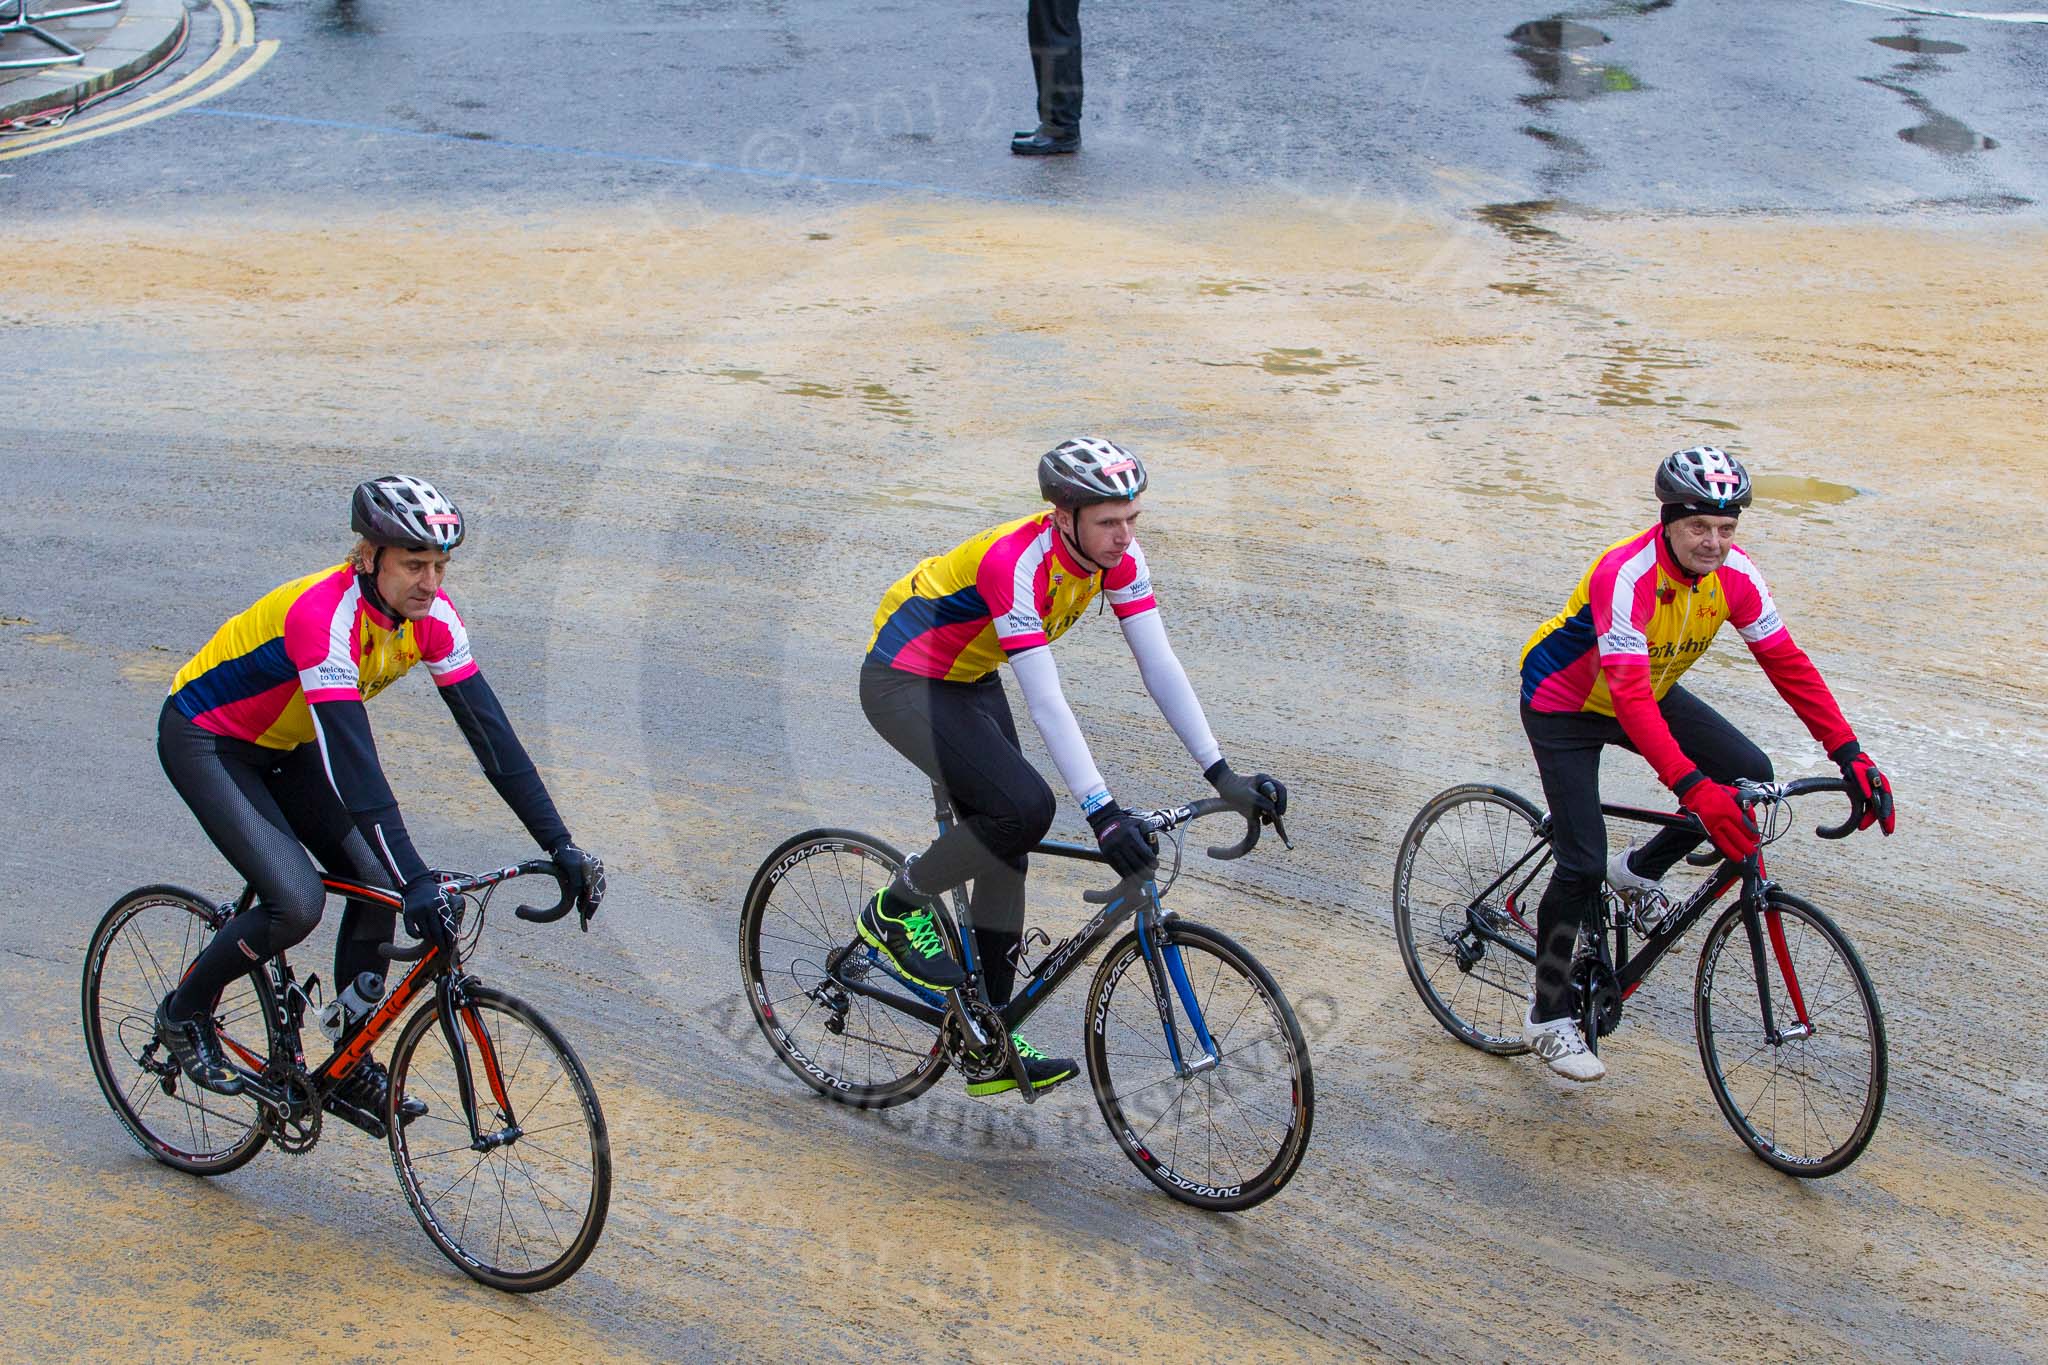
[{"left": 1694, "top": 890, "right": 1886, "bottom": 1177}]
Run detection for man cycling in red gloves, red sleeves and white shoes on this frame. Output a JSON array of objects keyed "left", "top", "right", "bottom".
[{"left": 1522, "top": 446, "right": 1894, "bottom": 1081}]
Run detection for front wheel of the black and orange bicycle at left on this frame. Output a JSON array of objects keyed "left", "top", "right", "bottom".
[{"left": 385, "top": 984, "right": 612, "bottom": 1293}]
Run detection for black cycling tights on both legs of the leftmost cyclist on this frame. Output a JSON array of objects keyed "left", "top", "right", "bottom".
[{"left": 156, "top": 700, "right": 395, "bottom": 1019}]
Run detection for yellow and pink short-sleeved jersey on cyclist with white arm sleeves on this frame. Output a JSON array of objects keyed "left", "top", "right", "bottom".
[{"left": 868, "top": 512, "right": 1157, "bottom": 681}]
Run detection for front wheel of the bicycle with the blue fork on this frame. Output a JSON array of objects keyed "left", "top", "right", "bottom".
[{"left": 1085, "top": 919, "right": 1315, "bottom": 1212}]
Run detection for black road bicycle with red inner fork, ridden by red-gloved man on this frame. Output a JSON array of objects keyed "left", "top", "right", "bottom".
[{"left": 1395, "top": 778, "right": 1886, "bottom": 1177}]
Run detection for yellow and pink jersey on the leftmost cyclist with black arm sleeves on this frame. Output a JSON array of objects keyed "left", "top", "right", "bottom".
[{"left": 170, "top": 565, "right": 477, "bottom": 749}]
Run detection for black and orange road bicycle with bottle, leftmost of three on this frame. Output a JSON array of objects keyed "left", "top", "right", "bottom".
[{"left": 82, "top": 857, "right": 612, "bottom": 1293}]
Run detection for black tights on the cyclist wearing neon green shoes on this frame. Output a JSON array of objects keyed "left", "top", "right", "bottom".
[{"left": 860, "top": 663, "right": 1055, "bottom": 1005}]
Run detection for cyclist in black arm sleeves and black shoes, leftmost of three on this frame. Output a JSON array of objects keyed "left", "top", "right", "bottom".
[{"left": 158, "top": 475, "right": 604, "bottom": 1134}]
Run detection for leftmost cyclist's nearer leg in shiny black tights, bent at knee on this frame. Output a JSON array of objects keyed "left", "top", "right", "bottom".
[{"left": 156, "top": 702, "right": 328, "bottom": 1019}]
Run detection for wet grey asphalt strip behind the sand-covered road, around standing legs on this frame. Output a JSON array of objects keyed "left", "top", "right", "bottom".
[{"left": 0, "top": 0, "right": 2048, "bottom": 215}]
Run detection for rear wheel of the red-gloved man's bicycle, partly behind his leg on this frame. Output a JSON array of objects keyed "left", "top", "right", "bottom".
[{"left": 1395, "top": 784, "right": 1542, "bottom": 1056}]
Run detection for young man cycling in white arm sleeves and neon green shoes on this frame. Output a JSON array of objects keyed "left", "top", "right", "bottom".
[{"left": 860, "top": 436, "right": 1286, "bottom": 1095}]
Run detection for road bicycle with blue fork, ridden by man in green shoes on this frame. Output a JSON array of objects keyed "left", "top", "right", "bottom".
[{"left": 739, "top": 788, "right": 1315, "bottom": 1209}]
